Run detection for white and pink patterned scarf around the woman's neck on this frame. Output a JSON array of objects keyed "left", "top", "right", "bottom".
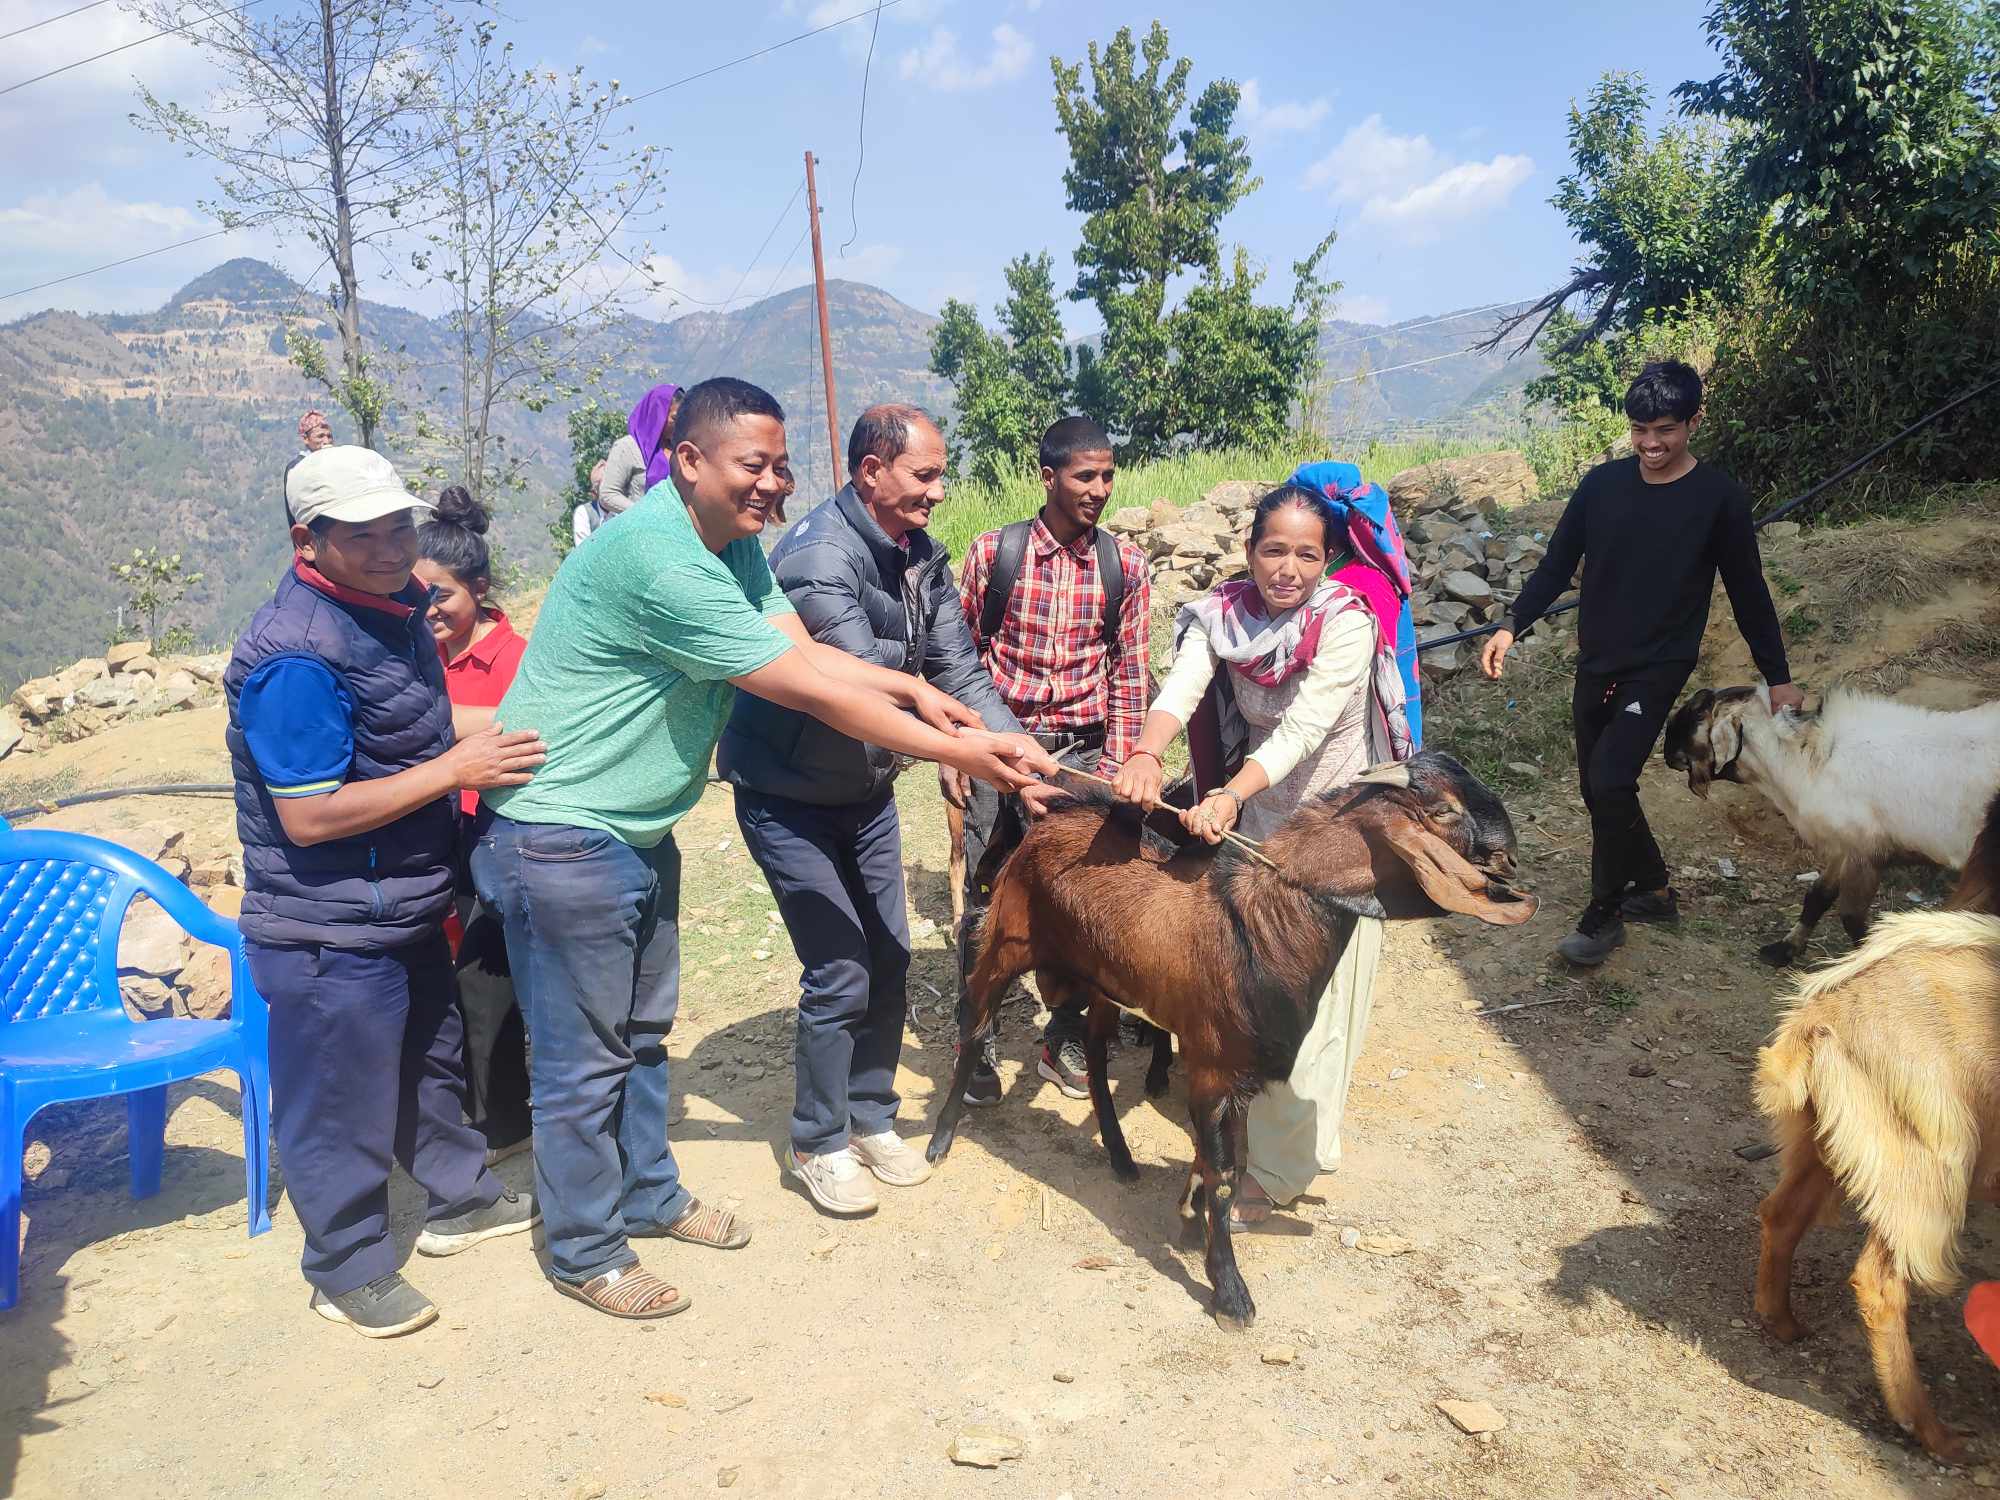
[{"left": 1174, "top": 578, "right": 1416, "bottom": 760}]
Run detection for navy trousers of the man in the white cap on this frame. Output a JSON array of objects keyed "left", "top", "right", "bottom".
[{"left": 244, "top": 928, "right": 500, "bottom": 1296}]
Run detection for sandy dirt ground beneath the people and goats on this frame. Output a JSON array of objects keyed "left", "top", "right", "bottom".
[{"left": 0, "top": 482, "right": 2000, "bottom": 1500}]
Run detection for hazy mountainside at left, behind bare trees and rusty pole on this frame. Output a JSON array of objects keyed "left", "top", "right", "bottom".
[{"left": 0, "top": 260, "right": 946, "bottom": 690}]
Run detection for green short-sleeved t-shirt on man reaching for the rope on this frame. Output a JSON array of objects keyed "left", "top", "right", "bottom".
[{"left": 480, "top": 494, "right": 792, "bottom": 848}]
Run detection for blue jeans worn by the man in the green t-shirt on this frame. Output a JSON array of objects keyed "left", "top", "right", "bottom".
[{"left": 472, "top": 816, "right": 690, "bottom": 1282}]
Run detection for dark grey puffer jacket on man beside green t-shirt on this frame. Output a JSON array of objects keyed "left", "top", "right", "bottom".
[{"left": 716, "top": 484, "right": 1020, "bottom": 806}]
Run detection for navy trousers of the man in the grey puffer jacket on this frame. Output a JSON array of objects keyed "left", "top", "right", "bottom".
[{"left": 736, "top": 786, "right": 910, "bottom": 1156}]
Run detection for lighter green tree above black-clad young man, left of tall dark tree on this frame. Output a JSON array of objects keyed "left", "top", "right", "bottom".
[{"left": 1480, "top": 72, "right": 1760, "bottom": 356}]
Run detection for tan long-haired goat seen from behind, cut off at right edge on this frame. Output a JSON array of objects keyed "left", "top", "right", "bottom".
[{"left": 1756, "top": 796, "right": 2000, "bottom": 1462}]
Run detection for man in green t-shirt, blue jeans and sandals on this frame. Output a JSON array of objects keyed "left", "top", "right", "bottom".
[{"left": 472, "top": 378, "right": 1056, "bottom": 1318}]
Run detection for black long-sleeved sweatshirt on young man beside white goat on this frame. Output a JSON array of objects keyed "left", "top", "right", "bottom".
[{"left": 1508, "top": 456, "right": 1792, "bottom": 686}]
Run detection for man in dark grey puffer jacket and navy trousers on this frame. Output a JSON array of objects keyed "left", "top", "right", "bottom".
[{"left": 716, "top": 406, "right": 1020, "bottom": 1214}]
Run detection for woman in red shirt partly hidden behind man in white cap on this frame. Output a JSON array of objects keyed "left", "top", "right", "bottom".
[{"left": 414, "top": 494, "right": 530, "bottom": 1164}]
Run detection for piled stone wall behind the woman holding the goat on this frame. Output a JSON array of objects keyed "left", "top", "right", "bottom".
[{"left": 1104, "top": 450, "right": 1568, "bottom": 682}]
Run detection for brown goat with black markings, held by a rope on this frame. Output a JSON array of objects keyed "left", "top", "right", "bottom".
[{"left": 926, "top": 752, "right": 1534, "bottom": 1328}]
